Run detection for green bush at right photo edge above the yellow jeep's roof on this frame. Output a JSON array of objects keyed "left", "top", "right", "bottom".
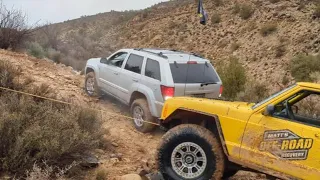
[{"left": 290, "top": 54, "right": 320, "bottom": 81}]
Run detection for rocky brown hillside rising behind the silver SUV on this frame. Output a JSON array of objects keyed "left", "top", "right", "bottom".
[{"left": 33, "top": 0, "right": 320, "bottom": 90}]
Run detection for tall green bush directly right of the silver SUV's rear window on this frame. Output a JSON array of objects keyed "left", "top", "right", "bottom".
[{"left": 218, "top": 57, "right": 247, "bottom": 100}]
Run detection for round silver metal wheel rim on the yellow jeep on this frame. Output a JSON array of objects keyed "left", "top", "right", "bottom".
[{"left": 171, "top": 142, "right": 207, "bottom": 179}]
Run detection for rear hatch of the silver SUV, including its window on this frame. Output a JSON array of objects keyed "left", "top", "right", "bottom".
[{"left": 170, "top": 60, "right": 222, "bottom": 98}]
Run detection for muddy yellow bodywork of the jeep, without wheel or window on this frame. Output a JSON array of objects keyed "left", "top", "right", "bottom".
[{"left": 161, "top": 83, "right": 320, "bottom": 179}]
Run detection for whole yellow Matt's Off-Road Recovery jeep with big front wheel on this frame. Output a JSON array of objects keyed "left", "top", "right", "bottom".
[{"left": 157, "top": 83, "right": 320, "bottom": 180}]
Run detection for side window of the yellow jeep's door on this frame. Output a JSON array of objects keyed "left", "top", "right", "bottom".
[{"left": 274, "top": 91, "right": 320, "bottom": 126}]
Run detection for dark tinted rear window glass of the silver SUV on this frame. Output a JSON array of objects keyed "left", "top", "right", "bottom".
[{"left": 170, "top": 63, "right": 219, "bottom": 84}]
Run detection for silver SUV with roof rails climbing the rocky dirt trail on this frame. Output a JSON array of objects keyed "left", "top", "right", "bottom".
[{"left": 85, "top": 49, "right": 223, "bottom": 132}]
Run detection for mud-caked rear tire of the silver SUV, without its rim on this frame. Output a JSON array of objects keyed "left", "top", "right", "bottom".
[{"left": 130, "top": 99, "right": 156, "bottom": 133}]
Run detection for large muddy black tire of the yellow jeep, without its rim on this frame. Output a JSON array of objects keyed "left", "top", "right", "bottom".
[{"left": 156, "top": 124, "right": 225, "bottom": 180}]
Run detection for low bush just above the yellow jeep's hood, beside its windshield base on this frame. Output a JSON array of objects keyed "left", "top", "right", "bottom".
[{"left": 237, "top": 81, "right": 269, "bottom": 103}]
